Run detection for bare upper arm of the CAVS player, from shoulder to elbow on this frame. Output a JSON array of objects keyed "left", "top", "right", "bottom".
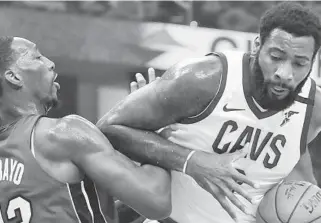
[{"left": 97, "top": 55, "right": 224, "bottom": 131}]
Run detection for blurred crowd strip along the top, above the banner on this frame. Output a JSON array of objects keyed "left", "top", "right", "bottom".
[{"left": 0, "top": 1, "right": 321, "bottom": 32}]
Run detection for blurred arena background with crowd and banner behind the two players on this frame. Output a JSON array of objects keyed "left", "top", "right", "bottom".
[{"left": 0, "top": 1, "right": 321, "bottom": 223}]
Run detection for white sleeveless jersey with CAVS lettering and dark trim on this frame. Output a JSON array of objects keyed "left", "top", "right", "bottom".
[{"left": 167, "top": 52, "right": 315, "bottom": 223}]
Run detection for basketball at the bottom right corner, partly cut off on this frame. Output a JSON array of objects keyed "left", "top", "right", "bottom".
[{"left": 256, "top": 181, "right": 321, "bottom": 223}]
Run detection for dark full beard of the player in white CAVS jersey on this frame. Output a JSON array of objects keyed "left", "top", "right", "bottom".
[{"left": 252, "top": 52, "right": 311, "bottom": 111}]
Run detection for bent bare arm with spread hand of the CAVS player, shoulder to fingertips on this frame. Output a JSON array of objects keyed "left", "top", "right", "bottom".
[{"left": 97, "top": 57, "right": 254, "bottom": 220}]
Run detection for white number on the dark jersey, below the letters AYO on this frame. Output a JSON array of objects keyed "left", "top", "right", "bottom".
[{"left": 0, "top": 197, "right": 32, "bottom": 223}]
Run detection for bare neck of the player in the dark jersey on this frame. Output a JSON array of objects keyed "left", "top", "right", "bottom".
[{"left": 0, "top": 94, "right": 47, "bottom": 126}]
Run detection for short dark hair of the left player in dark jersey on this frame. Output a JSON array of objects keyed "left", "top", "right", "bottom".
[{"left": 0, "top": 36, "right": 15, "bottom": 96}]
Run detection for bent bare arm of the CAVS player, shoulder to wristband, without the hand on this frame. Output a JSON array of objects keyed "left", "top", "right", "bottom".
[{"left": 97, "top": 56, "right": 222, "bottom": 171}]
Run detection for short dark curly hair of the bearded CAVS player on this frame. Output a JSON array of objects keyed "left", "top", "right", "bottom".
[{"left": 259, "top": 1, "right": 321, "bottom": 58}]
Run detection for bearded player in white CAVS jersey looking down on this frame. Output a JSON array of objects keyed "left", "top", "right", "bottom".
[{"left": 97, "top": 2, "right": 321, "bottom": 223}]
